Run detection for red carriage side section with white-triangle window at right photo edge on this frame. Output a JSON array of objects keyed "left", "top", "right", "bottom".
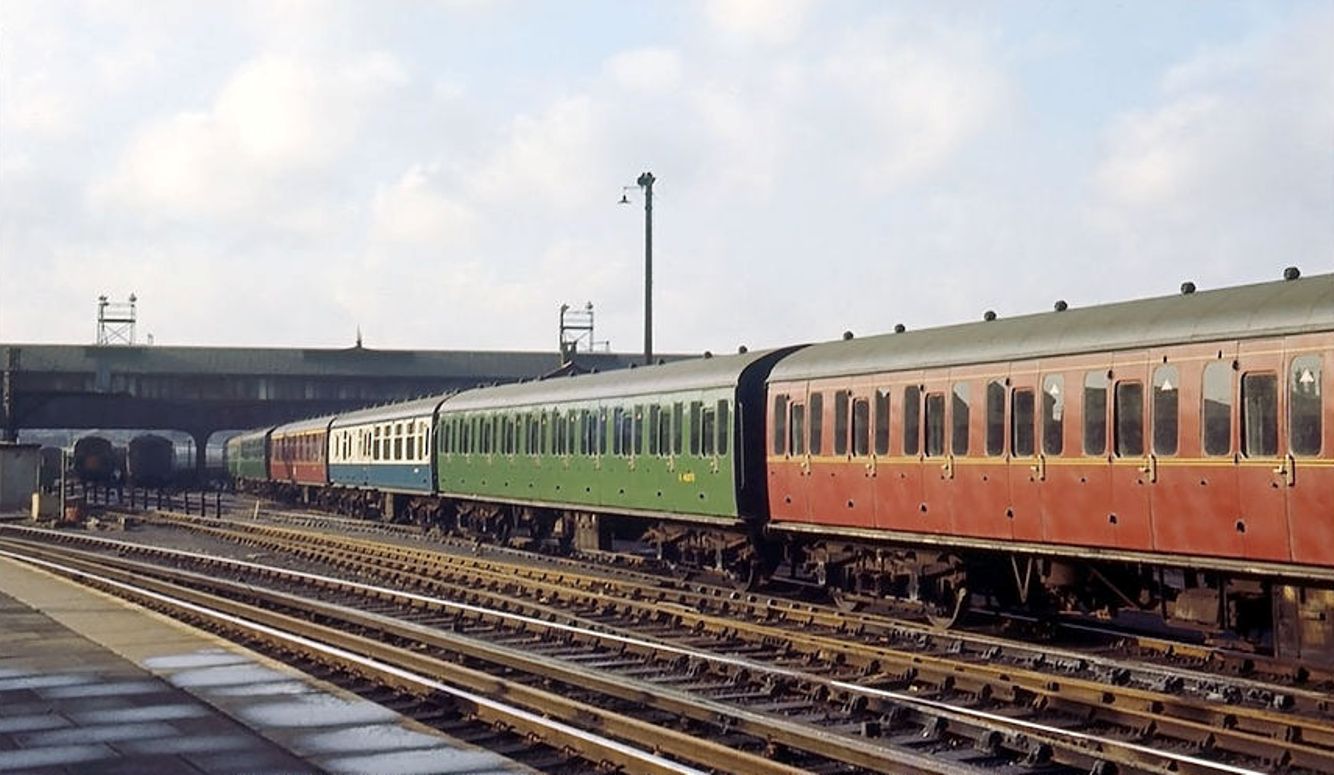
[{"left": 1286, "top": 343, "right": 1334, "bottom": 564}]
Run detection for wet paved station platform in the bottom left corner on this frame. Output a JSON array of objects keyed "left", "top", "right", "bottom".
[{"left": 0, "top": 558, "right": 523, "bottom": 775}]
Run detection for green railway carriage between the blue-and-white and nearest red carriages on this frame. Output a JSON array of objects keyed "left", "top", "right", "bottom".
[{"left": 436, "top": 351, "right": 788, "bottom": 574}]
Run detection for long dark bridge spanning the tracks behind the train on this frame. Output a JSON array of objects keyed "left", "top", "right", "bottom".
[{"left": 0, "top": 344, "right": 667, "bottom": 471}]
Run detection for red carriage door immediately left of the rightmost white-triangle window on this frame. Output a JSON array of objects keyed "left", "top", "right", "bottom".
[{"left": 1233, "top": 340, "right": 1297, "bottom": 560}]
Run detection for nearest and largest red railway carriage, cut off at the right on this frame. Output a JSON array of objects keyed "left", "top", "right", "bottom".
[{"left": 767, "top": 276, "right": 1334, "bottom": 658}]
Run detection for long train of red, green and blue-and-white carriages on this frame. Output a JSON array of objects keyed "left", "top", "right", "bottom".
[{"left": 227, "top": 269, "right": 1334, "bottom": 663}]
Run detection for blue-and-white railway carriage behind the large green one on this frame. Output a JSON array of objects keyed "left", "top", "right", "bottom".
[{"left": 328, "top": 396, "right": 446, "bottom": 515}]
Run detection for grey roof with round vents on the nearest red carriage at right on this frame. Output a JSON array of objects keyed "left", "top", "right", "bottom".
[{"left": 770, "top": 275, "right": 1334, "bottom": 381}]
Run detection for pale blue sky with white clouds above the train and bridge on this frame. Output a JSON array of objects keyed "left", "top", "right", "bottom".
[{"left": 0, "top": 0, "right": 1334, "bottom": 352}]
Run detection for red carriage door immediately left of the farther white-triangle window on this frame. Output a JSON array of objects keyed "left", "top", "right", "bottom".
[{"left": 1106, "top": 353, "right": 1157, "bottom": 551}]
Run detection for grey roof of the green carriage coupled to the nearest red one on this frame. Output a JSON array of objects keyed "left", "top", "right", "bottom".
[{"left": 443, "top": 351, "right": 789, "bottom": 412}]
